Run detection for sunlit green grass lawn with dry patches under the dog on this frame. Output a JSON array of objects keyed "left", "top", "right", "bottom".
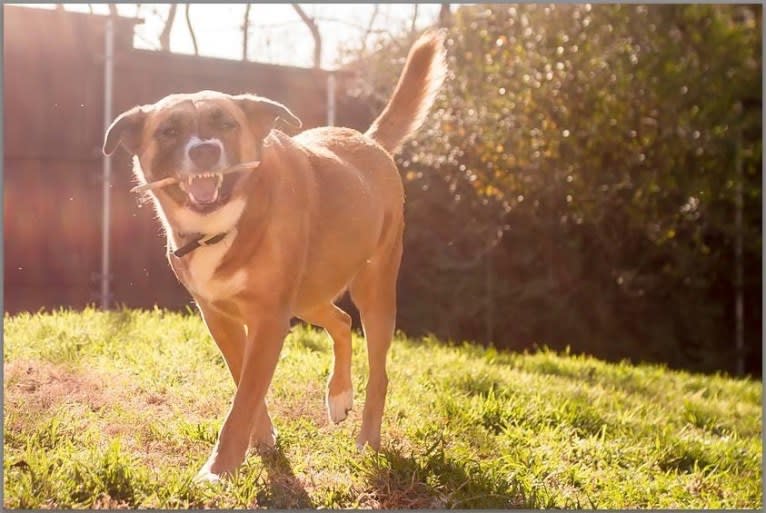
[{"left": 4, "top": 310, "right": 763, "bottom": 509}]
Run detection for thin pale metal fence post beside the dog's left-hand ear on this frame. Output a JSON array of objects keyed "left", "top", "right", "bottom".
[{"left": 101, "top": 16, "right": 114, "bottom": 310}]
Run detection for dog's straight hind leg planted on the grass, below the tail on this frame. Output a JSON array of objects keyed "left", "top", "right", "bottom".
[{"left": 349, "top": 219, "right": 404, "bottom": 450}]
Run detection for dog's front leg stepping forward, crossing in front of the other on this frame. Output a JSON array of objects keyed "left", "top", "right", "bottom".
[{"left": 197, "top": 310, "right": 290, "bottom": 480}]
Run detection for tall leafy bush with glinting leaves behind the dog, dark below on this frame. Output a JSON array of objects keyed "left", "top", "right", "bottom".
[{"left": 348, "top": 4, "right": 762, "bottom": 373}]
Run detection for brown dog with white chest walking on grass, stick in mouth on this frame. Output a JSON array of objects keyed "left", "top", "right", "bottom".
[{"left": 104, "top": 32, "right": 446, "bottom": 480}]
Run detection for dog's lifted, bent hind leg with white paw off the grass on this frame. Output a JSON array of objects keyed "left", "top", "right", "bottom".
[{"left": 299, "top": 303, "right": 354, "bottom": 424}]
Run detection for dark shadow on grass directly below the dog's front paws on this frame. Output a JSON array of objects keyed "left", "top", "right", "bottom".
[{"left": 256, "top": 444, "right": 316, "bottom": 509}]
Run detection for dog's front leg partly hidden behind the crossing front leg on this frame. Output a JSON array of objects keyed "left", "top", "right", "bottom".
[{"left": 197, "top": 301, "right": 277, "bottom": 449}]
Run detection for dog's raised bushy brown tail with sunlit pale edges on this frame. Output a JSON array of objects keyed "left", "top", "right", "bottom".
[{"left": 365, "top": 30, "right": 447, "bottom": 153}]
